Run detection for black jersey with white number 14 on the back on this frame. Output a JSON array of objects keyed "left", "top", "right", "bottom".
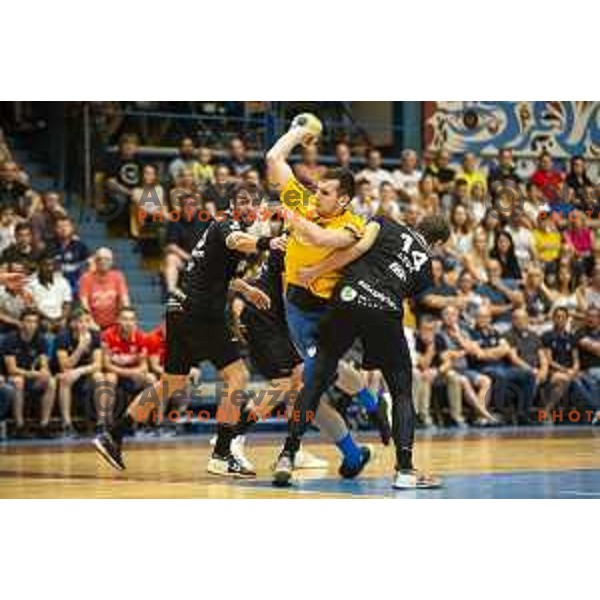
[{"left": 335, "top": 217, "right": 431, "bottom": 312}]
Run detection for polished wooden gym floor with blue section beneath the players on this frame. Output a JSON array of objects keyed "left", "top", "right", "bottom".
[{"left": 0, "top": 426, "right": 600, "bottom": 499}]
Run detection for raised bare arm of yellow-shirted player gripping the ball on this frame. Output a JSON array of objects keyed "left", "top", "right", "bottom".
[{"left": 267, "top": 114, "right": 322, "bottom": 200}]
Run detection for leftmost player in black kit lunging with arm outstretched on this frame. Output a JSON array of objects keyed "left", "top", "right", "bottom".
[{"left": 94, "top": 185, "right": 285, "bottom": 477}]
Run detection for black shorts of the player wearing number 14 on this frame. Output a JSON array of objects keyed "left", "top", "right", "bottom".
[{"left": 318, "top": 306, "right": 412, "bottom": 371}]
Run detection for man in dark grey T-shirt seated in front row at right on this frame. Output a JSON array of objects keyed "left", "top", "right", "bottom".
[{"left": 505, "top": 308, "right": 549, "bottom": 396}]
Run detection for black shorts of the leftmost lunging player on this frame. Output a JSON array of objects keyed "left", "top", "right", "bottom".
[{"left": 165, "top": 310, "right": 240, "bottom": 375}]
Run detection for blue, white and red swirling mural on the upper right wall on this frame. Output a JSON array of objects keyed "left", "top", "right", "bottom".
[{"left": 425, "top": 101, "right": 600, "bottom": 160}]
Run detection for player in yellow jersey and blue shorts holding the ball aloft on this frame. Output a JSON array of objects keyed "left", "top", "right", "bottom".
[{"left": 267, "top": 115, "right": 389, "bottom": 478}]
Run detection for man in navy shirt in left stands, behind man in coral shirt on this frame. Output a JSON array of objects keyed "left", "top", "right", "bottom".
[{"left": 48, "top": 215, "right": 90, "bottom": 296}]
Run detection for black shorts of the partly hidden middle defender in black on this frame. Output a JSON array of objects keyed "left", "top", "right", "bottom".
[{"left": 240, "top": 304, "right": 302, "bottom": 380}]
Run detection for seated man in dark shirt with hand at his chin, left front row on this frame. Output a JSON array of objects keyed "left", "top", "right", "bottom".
[{"left": 56, "top": 308, "right": 104, "bottom": 438}]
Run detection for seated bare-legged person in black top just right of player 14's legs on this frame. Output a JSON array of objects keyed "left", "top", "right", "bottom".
[{"left": 415, "top": 319, "right": 465, "bottom": 428}]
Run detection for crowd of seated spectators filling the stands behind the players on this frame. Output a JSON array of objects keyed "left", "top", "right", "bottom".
[{"left": 0, "top": 122, "right": 600, "bottom": 434}]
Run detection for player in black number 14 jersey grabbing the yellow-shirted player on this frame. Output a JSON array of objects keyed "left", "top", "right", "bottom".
[{"left": 273, "top": 216, "right": 450, "bottom": 489}]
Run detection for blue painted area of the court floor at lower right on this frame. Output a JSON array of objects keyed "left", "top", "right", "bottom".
[{"left": 241, "top": 469, "right": 600, "bottom": 499}]
